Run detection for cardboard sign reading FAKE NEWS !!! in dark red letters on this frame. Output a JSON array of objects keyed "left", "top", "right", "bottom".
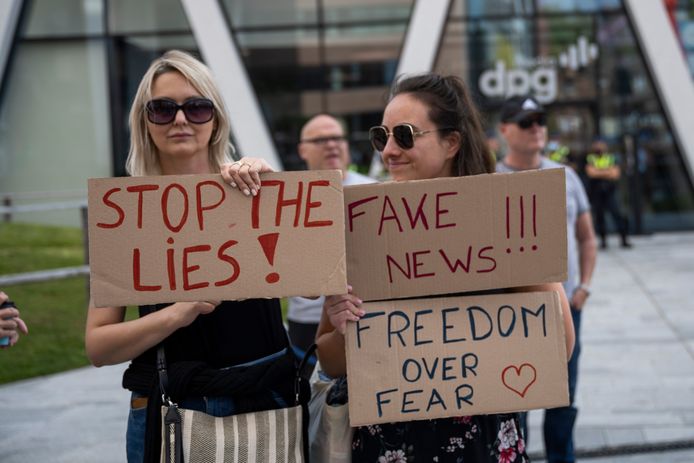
[{"left": 345, "top": 169, "right": 567, "bottom": 301}]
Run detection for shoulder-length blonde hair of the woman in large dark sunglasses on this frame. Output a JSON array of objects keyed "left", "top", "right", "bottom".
[{"left": 125, "top": 50, "right": 234, "bottom": 177}]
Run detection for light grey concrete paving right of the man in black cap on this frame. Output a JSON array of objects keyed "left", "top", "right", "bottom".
[{"left": 529, "top": 233, "right": 694, "bottom": 461}]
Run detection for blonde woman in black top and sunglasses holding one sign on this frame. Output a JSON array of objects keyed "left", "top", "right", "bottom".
[{"left": 86, "top": 51, "right": 294, "bottom": 462}]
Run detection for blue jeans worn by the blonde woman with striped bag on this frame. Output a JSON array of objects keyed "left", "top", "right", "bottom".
[{"left": 125, "top": 350, "right": 287, "bottom": 463}]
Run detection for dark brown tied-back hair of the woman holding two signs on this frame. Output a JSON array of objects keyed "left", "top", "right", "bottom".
[{"left": 388, "top": 73, "right": 495, "bottom": 177}]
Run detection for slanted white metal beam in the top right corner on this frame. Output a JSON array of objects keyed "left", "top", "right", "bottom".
[{"left": 624, "top": 0, "right": 694, "bottom": 180}]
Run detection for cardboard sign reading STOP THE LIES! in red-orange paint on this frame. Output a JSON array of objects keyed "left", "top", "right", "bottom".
[{"left": 89, "top": 170, "right": 347, "bottom": 307}]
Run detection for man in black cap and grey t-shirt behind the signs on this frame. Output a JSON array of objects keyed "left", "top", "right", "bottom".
[{"left": 496, "top": 96, "right": 597, "bottom": 463}]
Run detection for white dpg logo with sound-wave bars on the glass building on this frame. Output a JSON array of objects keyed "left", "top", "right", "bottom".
[{"left": 478, "top": 36, "right": 598, "bottom": 104}]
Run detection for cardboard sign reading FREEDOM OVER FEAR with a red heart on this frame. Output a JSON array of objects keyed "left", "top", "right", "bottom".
[{"left": 346, "top": 292, "right": 569, "bottom": 426}]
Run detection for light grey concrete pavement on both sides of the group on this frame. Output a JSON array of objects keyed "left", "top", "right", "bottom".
[{"left": 0, "top": 233, "right": 694, "bottom": 463}]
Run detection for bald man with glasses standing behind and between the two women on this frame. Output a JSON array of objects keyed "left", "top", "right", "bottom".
[{"left": 287, "top": 114, "right": 374, "bottom": 354}]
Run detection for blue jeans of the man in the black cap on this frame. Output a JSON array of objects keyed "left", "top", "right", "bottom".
[{"left": 543, "top": 307, "right": 581, "bottom": 463}]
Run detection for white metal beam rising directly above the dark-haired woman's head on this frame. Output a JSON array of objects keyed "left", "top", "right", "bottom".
[{"left": 397, "top": 0, "right": 451, "bottom": 75}]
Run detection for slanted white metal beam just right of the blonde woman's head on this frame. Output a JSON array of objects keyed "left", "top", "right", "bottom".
[{"left": 182, "top": 0, "right": 282, "bottom": 170}]
